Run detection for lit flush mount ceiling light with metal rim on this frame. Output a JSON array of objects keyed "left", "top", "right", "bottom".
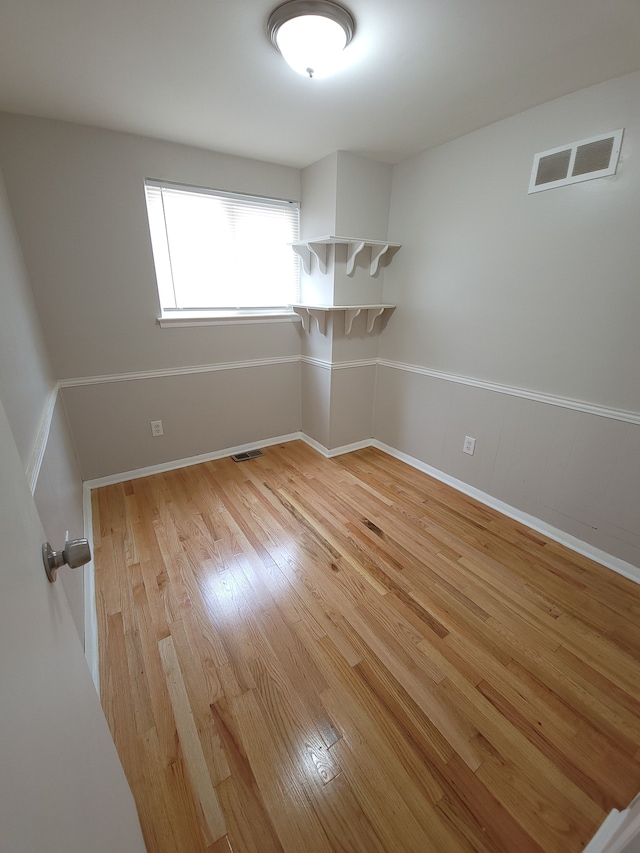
[{"left": 267, "top": 0, "right": 356, "bottom": 77}]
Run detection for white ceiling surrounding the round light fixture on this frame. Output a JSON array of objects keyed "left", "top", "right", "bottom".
[{"left": 0, "top": 0, "right": 640, "bottom": 167}]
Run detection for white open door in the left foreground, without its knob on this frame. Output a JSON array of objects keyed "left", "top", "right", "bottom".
[{"left": 0, "top": 402, "right": 145, "bottom": 853}]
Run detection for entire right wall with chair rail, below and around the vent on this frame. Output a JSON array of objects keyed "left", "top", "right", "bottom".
[{"left": 374, "top": 74, "right": 640, "bottom": 566}]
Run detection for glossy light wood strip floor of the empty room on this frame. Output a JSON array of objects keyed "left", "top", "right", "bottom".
[{"left": 93, "top": 442, "right": 640, "bottom": 853}]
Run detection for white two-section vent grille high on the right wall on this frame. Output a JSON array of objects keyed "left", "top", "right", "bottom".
[{"left": 529, "top": 130, "right": 623, "bottom": 193}]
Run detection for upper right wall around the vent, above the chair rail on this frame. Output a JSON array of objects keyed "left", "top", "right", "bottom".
[{"left": 381, "top": 74, "right": 640, "bottom": 411}]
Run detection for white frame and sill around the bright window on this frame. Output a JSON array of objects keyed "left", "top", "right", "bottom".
[{"left": 144, "top": 178, "right": 300, "bottom": 328}]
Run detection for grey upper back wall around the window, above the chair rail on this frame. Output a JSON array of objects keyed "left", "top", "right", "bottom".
[{"left": 0, "top": 114, "right": 300, "bottom": 379}]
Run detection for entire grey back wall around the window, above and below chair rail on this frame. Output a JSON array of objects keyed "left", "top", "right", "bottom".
[{"left": 0, "top": 114, "right": 300, "bottom": 479}]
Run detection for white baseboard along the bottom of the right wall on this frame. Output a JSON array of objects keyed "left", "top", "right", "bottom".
[{"left": 369, "top": 439, "right": 640, "bottom": 583}]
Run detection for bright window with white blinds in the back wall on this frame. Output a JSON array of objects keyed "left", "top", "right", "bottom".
[{"left": 145, "top": 180, "right": 300, "bottom": 317}]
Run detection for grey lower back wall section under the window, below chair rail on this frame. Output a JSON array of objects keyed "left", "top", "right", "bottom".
[{"left": 61, "top": 361, "right": 300, "bottom": 480}]
